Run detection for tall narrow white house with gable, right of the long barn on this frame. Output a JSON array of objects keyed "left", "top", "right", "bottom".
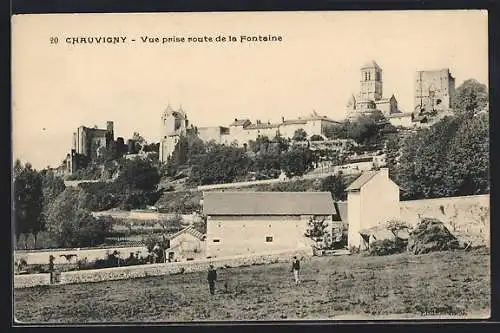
[{"left": 346, "top": 168, "right": 400, "bottom": 249}]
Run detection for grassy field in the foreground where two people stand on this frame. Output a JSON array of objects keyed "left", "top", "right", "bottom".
[{"left": 14, "top": 249, "right": 490, "bottom": 323}]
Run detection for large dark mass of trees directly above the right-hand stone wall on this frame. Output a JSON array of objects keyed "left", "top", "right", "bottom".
[{"left": 396, "top": 114, "right": 489, "bottom": 199}]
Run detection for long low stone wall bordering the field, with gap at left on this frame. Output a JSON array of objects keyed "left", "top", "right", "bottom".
[{"left": 14, "top": 246, "right": 312, "bottom": 288}]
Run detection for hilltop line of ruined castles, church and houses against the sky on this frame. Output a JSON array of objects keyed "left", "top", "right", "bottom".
[{"left": 57, "top": 61, "right": 464, "bottom": 175}]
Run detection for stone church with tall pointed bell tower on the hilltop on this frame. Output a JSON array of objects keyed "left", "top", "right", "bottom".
[{"left": 346, "top": 60, "right": 400, "bottom": 119}]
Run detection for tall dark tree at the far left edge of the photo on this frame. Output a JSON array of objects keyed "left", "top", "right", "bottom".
[{"left": 14, "top": 160, "right": 44, "bottom": 243}]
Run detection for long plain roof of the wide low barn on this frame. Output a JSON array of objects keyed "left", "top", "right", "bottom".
[{"left": 203, "top": 191, "right": 336, "bottom": 215}]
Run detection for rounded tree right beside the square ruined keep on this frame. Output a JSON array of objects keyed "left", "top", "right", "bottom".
[{"left": 452, "top": 79, "right": 489, "bottom": 113}]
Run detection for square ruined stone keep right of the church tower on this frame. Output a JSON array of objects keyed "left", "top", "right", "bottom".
[{"left": 414, "top": 68, "right": 455, "bottom": 114}]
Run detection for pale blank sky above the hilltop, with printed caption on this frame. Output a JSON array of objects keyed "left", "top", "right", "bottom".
[{"left": 12, "top": 10, "right": 488, "bottom": 169}]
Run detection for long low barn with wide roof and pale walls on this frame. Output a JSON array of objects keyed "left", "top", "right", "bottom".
[{"left": 203, "top": 192, "right": 336, "bottom": 257}]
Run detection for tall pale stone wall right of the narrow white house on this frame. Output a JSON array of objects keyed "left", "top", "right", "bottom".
[{"left": 400, "top": 194, "right": 490, "bottom": 246}]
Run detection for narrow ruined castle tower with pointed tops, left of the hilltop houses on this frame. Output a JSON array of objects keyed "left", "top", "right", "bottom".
[{"left": 159, "top": 105, "right": 188, "bottom": 162}]
